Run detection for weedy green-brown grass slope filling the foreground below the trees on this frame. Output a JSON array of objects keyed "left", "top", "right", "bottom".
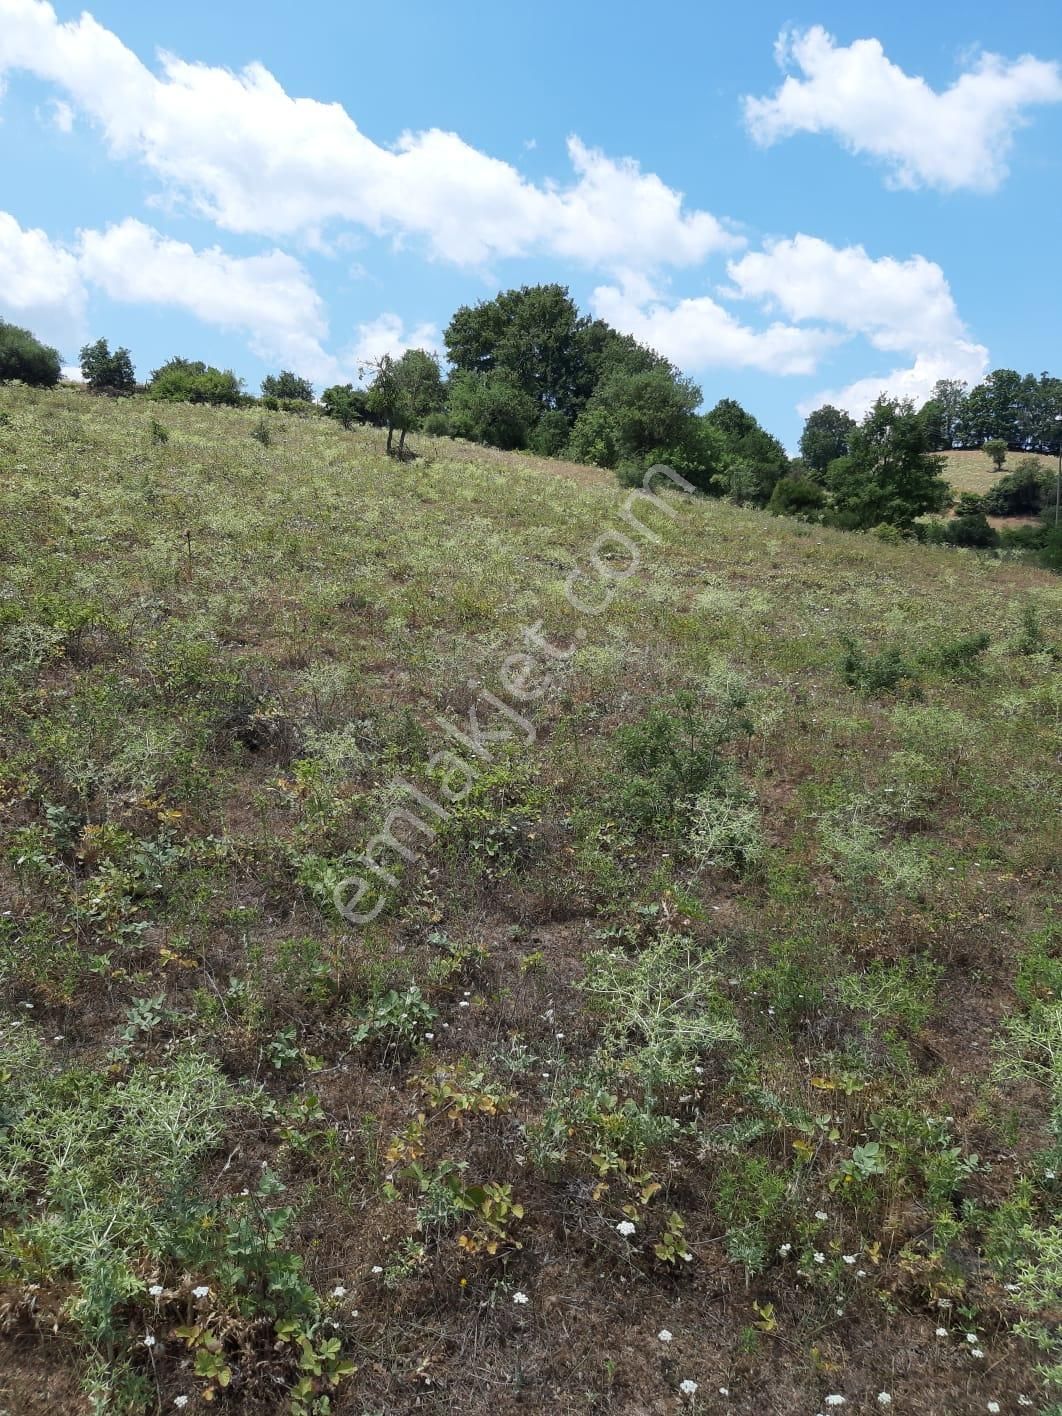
[{"left": 0, "top": 388, "right": 1062, "bottom": 1416}]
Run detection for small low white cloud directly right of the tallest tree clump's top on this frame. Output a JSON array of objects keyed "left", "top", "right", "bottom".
[{"left": 590, "top": 280, "right": 838, "bottom": 374}]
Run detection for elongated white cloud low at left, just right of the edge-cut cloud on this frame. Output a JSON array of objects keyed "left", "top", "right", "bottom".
[{"left": 79, "top": 218, "right": 338, "bottom": 379}]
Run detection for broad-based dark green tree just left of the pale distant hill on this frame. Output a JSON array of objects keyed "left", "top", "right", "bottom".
[{"left": 827, "top": 396, "right": 952, "bottom": 530}]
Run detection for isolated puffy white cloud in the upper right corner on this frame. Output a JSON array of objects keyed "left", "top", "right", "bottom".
[{"left": 745, "top": 25, "right": 1062, "bottom": 191}]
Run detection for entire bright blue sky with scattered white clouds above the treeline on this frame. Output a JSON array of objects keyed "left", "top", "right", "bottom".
[{"left": 0, "top": 0, "right": 1062, "bottom": 446}]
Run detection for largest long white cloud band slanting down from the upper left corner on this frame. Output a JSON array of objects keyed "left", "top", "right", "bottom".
[{"left": 0, "top": 0, "right": 741, "bottom": 268}]
